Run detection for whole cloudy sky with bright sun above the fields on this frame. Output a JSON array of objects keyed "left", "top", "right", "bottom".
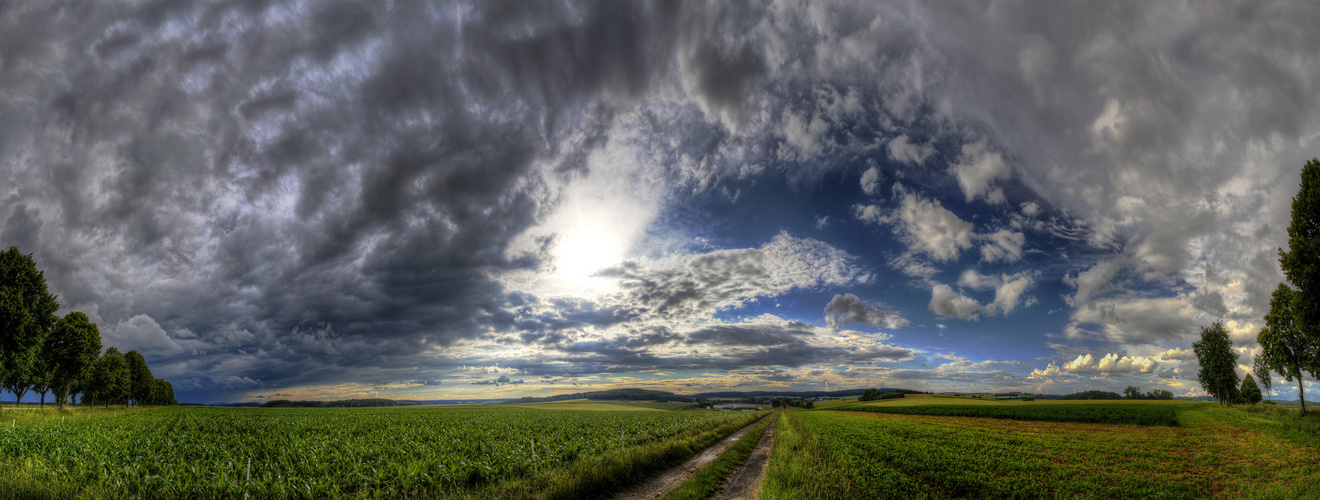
[{"left": 0, "top": 0, "right": 1320, "bottom": 402}]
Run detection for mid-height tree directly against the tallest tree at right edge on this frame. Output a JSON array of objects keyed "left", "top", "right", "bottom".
[{"left": 1255, "top": 284, "right": 1317, "bottom": 413}]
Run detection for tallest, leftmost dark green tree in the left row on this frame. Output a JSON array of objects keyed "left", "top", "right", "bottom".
[{"left": 0, "top": 247, "right": 59, "bottom": 405}]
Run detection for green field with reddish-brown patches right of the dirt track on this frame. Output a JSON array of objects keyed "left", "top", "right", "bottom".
[{"left": 762, "top": 402, "right": 1320, "bottom": 499}]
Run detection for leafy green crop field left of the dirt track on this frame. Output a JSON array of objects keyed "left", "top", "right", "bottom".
[{"left": 0, "top": 406, "right": 764, "bottom": 499}]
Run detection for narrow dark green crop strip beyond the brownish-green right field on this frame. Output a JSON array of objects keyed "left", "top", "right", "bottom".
[{"left": 837, "top": 405, "right": 1177, "bottom": 426}]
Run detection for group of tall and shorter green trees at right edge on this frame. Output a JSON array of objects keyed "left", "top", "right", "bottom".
[{"left": 1192, "top": 158, "right": 1320, "bottom": 413}]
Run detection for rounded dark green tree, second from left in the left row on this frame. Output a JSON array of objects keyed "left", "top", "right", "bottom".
[{"left": 42, "top": 311, "right": 100, "bottom": 410}]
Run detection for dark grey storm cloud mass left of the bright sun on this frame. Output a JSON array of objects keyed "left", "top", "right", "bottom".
[{"left": 0, "top": 1, "right": 755, "bottom": 398}]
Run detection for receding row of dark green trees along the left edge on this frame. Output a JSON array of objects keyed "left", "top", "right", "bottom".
[{"left": 0, "top": 247, "right": 176, "bottom": 409}]
